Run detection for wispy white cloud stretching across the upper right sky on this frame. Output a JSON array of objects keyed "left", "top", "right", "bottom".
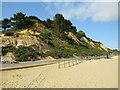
[{"left": 43, "top": 2, "right": 118, "bottom": 22}]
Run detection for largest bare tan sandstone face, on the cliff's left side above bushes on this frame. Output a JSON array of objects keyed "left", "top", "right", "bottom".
[{"left": 2, "top": 35, "right": 53, "bottom": 52}]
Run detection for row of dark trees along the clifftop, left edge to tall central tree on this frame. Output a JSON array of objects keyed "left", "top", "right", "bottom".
[{"left": 2, "top": 12, "right": 77, "bottom": 34}]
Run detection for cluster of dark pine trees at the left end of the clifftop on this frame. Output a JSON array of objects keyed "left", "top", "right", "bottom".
[{"left": 2, "top": 12, "right": 39, "bottom": 30}]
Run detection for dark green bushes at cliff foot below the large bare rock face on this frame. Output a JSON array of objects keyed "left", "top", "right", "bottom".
[{"left": 2, "top": 46, "right": 44, "bottom": 61}]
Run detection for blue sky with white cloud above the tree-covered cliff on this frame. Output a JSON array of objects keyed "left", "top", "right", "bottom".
[{"left": 2, "top": 2, "right": 118, "bottom": 49}]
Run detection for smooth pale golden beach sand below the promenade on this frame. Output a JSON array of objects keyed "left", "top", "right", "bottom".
[{"left": 2, "top": 56, "right": 118, "bottom": 88}]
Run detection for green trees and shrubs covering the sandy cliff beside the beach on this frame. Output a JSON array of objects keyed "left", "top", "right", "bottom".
[{"left": 2, "top": 12, "right": 117, "bottom": 61}]
